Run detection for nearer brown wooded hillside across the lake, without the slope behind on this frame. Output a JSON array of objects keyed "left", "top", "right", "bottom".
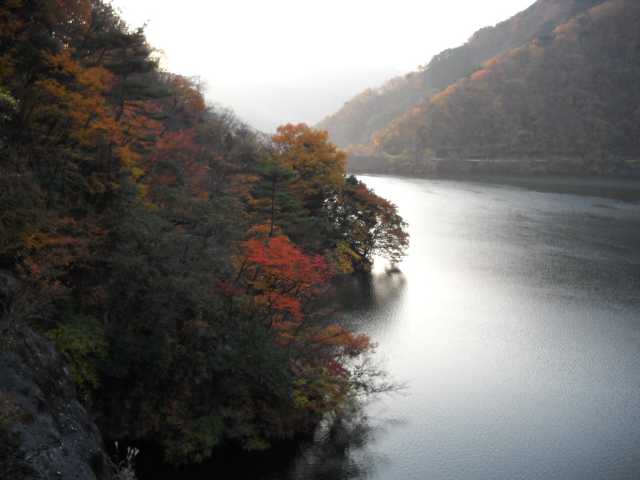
[{"left": 374, "top": 0, "right": 640, "bottom": 174}]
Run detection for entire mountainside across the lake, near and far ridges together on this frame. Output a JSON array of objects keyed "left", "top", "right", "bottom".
[{"left": 322, "top": 0, "right": 640, "bottom": 175}]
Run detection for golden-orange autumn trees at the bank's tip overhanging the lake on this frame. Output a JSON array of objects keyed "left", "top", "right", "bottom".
[{"left": 257, "top": 124, "right": 408, "bottom": 272}]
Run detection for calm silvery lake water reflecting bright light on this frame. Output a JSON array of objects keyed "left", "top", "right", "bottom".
[{"left": 288, "top": 177, "right": 640, "bottom": 480}]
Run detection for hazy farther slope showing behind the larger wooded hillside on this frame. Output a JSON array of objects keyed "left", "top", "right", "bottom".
[{"left": 318, "top": 0, "right": 603, "bottom": 147}]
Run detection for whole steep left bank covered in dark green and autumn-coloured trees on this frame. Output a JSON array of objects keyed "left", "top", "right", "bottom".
[{"left": 0, "top": 0, "right": 407, "bottom": 464}]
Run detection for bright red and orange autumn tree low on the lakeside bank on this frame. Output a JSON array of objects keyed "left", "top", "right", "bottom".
[{"left": 231, "top": 236, "right": 378, "bottom": 436}]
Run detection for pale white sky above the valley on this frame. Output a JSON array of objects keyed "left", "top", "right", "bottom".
[{"left": 113, "top": 0, "right": 534, "bottom": 132}]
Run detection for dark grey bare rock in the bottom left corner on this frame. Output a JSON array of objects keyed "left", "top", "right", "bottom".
[{"left": 0, "top": 316, "right": 111, "bottom": 480}]
